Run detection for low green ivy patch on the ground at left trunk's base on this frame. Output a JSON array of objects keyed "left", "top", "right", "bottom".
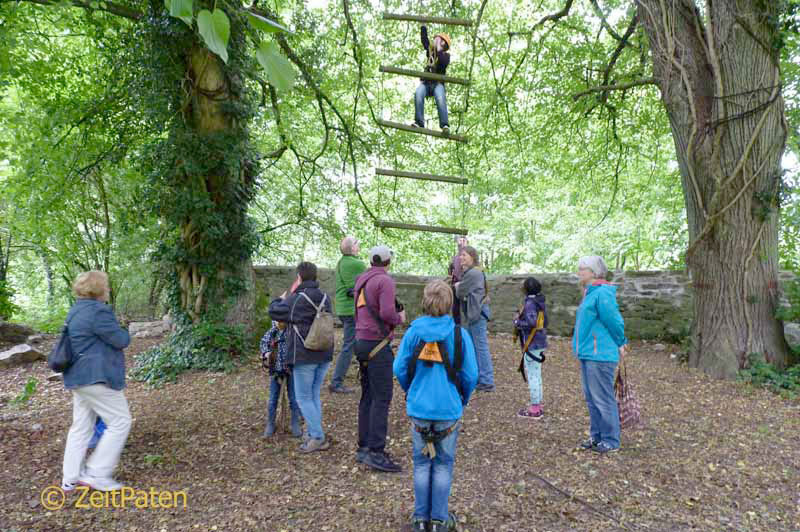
[{"left": 131, "top": 321, "right": 247, "bottom": 386}]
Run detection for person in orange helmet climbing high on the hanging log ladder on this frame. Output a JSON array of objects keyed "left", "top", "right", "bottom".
[{"left": 412, "top": 25, "right": 450, "bottom": 133}]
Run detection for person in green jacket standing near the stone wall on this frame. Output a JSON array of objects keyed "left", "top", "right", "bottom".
[{"left": 328, "top": 236, "right": 367, "bottom": 393}]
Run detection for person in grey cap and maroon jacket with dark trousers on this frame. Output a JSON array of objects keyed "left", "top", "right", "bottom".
[{"left": 353, "top": 246, "right": 406, "bottom": 473}]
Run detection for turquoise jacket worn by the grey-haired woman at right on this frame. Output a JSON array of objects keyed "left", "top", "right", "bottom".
[{"left": 572, "top": 281, "right": 628, "bottom": 362}]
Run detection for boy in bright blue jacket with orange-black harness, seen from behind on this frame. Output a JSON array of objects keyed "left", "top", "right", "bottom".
[{"left": 393, "top": 281, "right": 478, "bottom": 532}]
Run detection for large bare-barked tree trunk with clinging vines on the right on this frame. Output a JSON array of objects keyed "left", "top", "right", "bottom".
[{"left": 638, "top": 0, "right": 789, "bottom": 378}]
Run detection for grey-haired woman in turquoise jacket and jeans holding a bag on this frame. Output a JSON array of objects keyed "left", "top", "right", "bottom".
[{"left": 572, "top": 255, "right": 628, "bottom": 454}]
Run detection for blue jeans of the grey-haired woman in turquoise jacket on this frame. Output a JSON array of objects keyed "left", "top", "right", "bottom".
[{"left": 581, "top": 360, "right": 619, "bottom": 449}]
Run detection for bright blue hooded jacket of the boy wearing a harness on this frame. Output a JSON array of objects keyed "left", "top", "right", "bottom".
[{"left": 393, "top": 315, "right": 478, "bottom": 421}]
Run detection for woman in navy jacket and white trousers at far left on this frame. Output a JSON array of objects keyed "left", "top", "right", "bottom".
[{"left": 61, "top": 271, "right": 131, "bottom": 491}]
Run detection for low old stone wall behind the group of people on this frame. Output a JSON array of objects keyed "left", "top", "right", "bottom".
[{"left": 254, "top": 266, "right": 793, "bottom": 341}]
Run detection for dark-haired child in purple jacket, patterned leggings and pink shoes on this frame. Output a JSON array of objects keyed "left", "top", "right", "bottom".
[{"left": 514, "top": 277, "right": 547, "bottom": 419}]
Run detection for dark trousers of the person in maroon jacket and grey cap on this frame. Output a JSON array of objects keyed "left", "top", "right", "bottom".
[{"left": 356, "top": 340, "right": 394, "bottom": 452}]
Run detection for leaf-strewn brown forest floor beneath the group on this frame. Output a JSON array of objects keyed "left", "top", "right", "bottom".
[{"left": 0, "top": 335, "right": 800, "bottom": 532}]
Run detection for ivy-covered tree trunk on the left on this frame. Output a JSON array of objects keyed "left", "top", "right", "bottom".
[{"left": 144, "top": 7, "right": 257, "bottom": 328}]
